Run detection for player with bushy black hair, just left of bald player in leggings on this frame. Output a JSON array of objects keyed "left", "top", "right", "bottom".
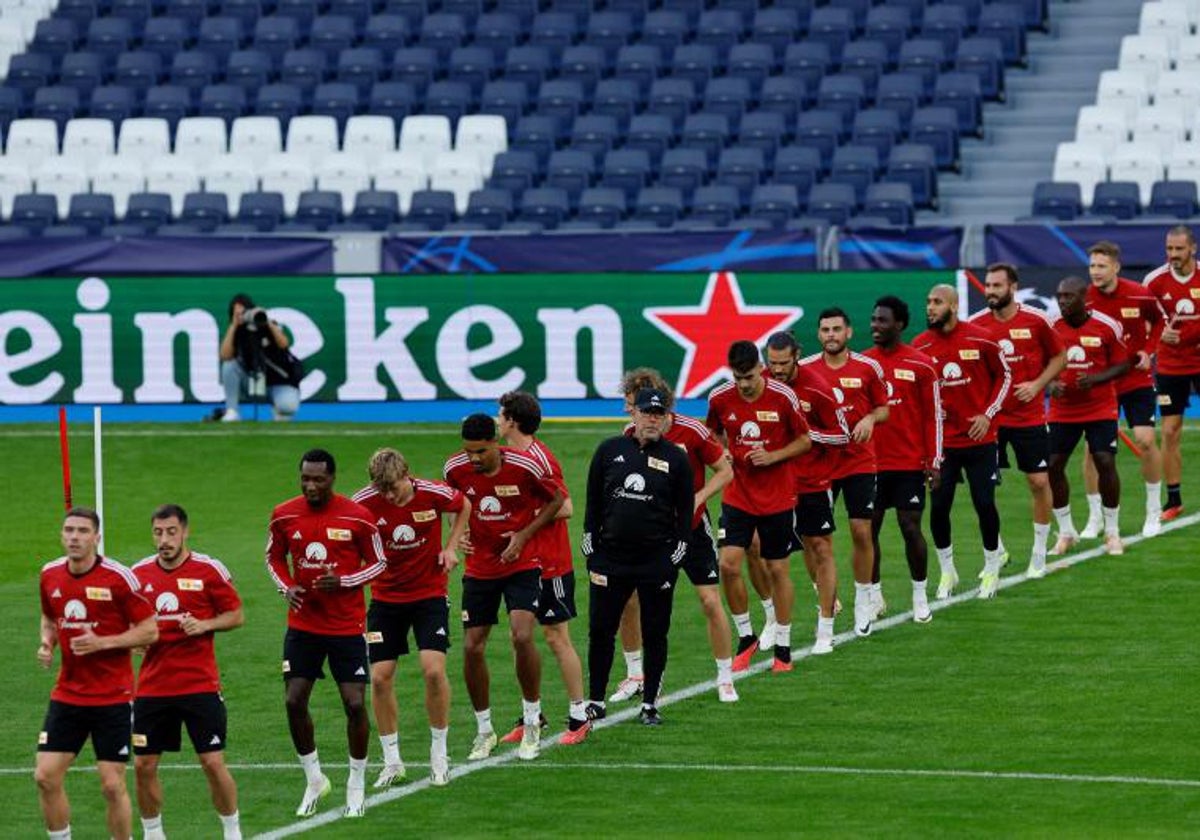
[{"left": 866, "top": 295, "right": 942, "bottom": 624}]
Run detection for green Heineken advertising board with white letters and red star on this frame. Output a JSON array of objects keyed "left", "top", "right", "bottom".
[{"left": 0, "top": 271, "right": 955, "bottom": 406}]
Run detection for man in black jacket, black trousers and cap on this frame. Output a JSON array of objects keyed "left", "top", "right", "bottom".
[{"left": 582, "top": 388, "right": 695, "bottom": 726}]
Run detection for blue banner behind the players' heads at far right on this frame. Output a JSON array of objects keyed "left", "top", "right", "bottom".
[{"left": 984, "top": 223, "right": 1171, "bottom": 268}]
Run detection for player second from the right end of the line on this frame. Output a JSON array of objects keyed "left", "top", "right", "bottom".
[{"left": 1080, "top": 241, "right": 1163, "bottom": 538}]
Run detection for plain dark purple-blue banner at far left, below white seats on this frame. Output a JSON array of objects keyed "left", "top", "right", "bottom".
[{"left": 0, "top": 236, "right": 334, "bottom": 277}]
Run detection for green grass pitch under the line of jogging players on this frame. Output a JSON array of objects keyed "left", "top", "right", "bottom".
[{"left": 0, "top": 424, "right": 1200, "bottom": 838}]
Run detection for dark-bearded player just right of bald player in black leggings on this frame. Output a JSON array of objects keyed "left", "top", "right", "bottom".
[{"left": 971, "top": 263, "right": 1067, "bottom": 578}]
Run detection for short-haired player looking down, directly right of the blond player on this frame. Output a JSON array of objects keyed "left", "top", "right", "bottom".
[{"left": 444, "top": 414, "right": 565, "bottom": 761}]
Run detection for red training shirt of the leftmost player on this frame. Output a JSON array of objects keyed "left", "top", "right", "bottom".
[{"left": 40, "top": 557, "right": 154, "bottom": 706}]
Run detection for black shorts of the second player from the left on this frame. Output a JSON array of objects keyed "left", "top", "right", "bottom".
[{"left": 133, "top": 691, "right": 226, "bottom": 756}]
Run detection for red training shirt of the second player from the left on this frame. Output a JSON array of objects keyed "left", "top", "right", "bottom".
[{"left": 133, "top": 551, "right": 241, "bottom": 697}]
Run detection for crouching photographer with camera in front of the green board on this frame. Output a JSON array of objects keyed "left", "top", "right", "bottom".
[{"left": 221, "top": 294, "right": 304, "bottom": 422}]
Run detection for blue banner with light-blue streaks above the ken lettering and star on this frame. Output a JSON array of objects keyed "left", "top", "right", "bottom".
[{"left": 383, "top": 230, "right": 818, "bottom": 274}]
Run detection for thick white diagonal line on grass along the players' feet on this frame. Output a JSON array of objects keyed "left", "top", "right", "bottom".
[{"left": 256, "top": 514, "right": 1200, "bottom": 840}]
